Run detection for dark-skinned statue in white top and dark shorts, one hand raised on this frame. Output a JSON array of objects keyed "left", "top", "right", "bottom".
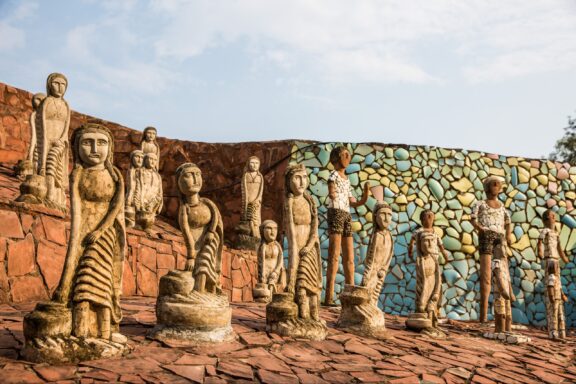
[{"left": 324, "top": 146, "right": 370, "bottom": 306}]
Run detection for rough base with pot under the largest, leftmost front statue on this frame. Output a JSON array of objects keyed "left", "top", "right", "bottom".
[{"left": 21, "top": 302, "right": 129, "bottom": 364}]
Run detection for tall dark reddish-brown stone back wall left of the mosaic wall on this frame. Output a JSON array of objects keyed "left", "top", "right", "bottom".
[{"left": 0, "top": 83, "right": 293, "bottom": 242}]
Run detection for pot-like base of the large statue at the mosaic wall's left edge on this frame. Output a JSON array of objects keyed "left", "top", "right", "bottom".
[{"left": 266, "top": 293, "right": 328, "bottom": 341}]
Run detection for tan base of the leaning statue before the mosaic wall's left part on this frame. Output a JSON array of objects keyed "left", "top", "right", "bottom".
[{"left": 336, "top": 285, "right": 392, "bottom": 340}]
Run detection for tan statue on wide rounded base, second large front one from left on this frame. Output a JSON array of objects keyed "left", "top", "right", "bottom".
[{"left": 150, "top": 163, "right": 235, "bottom": 345}]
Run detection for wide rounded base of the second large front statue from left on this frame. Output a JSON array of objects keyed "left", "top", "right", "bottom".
[{"left": 148, "top": 270, "right": 236, "bottom": 346}]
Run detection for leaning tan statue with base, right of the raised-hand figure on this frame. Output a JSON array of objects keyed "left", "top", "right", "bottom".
[{"left": 338, "top": 201, "right": 394, "bottom": 339}]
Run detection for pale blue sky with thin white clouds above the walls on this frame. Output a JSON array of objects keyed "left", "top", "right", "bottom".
[{"left": 0, "top": 0, "right": 576, "bottom": 157}]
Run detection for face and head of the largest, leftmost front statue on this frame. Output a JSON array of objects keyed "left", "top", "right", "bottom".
[{"left": 72, "top": 123, "right": 115, "bottom": 177}]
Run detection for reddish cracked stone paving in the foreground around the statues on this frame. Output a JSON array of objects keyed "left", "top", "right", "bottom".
[{"left": 0, "top": 298, "right": 576, "bottom": 384}]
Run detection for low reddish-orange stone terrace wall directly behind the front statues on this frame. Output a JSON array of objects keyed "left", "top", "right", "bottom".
[{"left": 0, "top": 168, "right": 258, "bottom": 303}]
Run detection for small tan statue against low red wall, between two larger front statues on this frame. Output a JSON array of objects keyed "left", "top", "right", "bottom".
[{"left": 252, "top": 220, "right": 285, "bottom": 303}]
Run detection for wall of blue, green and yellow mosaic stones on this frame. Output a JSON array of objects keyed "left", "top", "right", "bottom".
[{"left": 291, "top": 142, "right": 576, "bottom": 326}]
